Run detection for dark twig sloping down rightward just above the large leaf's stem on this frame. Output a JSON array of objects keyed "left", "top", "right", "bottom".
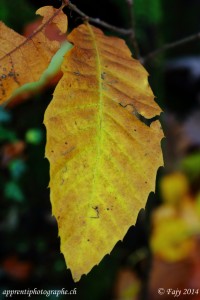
[{"left": 63, "top": 0, "right": 132, "bottom": 35}]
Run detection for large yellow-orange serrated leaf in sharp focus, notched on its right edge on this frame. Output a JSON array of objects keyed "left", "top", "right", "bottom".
[{"left": 45, "top": 24, "right": 163, "bottom": 281}]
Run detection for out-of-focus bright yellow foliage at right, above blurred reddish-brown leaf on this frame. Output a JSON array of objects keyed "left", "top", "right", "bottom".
[{"left": 151, "top": 173, "right": 200, "bottom": 261}]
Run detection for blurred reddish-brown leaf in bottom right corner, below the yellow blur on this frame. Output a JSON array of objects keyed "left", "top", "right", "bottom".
[{"left": 148, "top": 239, "right": 200, "bottom": 300}]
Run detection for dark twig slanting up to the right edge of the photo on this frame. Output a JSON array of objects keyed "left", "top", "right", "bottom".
[{"left": 140, "top": 32, "right": 200, "bottom": 64}]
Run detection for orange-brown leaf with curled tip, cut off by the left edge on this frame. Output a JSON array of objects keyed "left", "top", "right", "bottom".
[{"left": 0, "top": 6, "right": 67, "bottom": 104}]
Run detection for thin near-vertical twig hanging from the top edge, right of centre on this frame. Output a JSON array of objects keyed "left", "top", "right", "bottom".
[{"left": 126, "top": 0, "right": 140, "bottom": 59}]
